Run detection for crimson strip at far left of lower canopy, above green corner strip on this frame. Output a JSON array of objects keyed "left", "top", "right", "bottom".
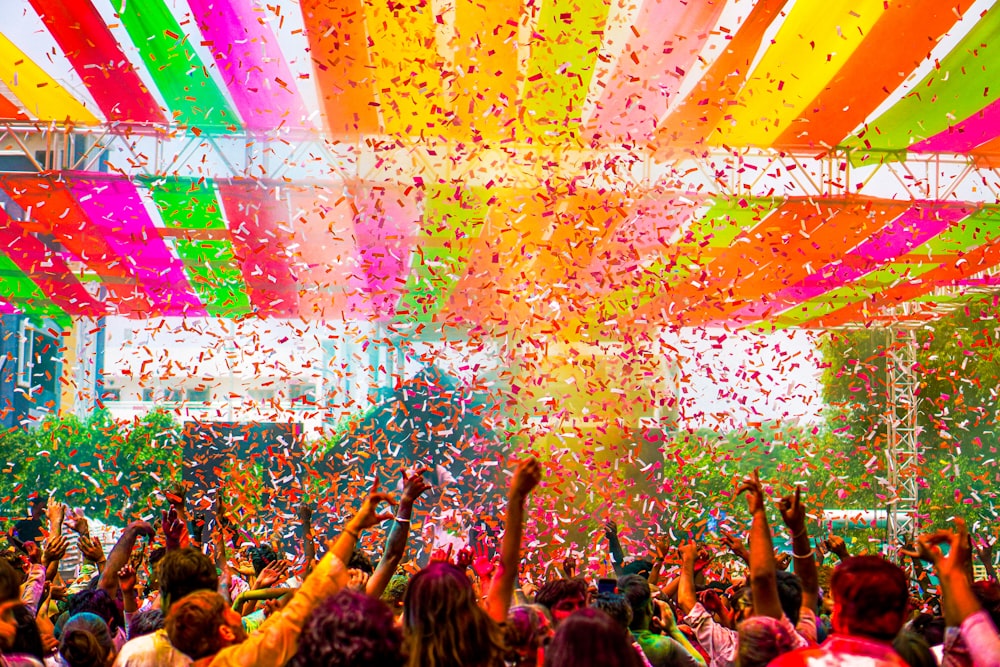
[{"left": 0, "top": 211, "right": 106, "bottom": 317}]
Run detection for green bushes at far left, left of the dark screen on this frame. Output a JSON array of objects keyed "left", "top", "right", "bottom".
[{"left": 0, "top": 410, "right": 182, "bottom": 523}]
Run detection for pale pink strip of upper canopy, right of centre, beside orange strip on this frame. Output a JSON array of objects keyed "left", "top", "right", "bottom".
[{"left": 587, "top": 0, "right": 726, "bottom": 140}]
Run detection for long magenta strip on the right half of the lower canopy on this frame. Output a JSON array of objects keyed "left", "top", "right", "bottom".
[{"left": 730, "top": 201, "right": 970, "bottom": 323}]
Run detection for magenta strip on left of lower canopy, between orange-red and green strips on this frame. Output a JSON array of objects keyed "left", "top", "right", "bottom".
[{"left": 65, "top": 172, "right": 205, "bottom": 316}]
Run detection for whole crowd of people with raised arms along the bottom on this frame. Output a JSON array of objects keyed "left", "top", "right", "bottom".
[{"left": 0, "top": 459, "right": 1000, "bottom": 667}]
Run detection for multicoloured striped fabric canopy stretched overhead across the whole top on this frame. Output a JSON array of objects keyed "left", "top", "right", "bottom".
[{"left": 0, "top": 0, "right": 1000, "bottom": 337}]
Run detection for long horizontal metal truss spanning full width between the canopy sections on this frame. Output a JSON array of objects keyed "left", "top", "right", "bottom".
[{"left": 0, "top": 123, "right": 1000, "bottom": 205}]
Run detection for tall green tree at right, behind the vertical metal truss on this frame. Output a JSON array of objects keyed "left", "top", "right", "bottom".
[{"left": 823, "top": 300, "right": 1000, "bottom": 529}]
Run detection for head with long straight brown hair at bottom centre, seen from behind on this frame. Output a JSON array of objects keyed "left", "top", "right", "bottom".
[{"left": 403, "top": 562, "right": 503, "bottom": 667}]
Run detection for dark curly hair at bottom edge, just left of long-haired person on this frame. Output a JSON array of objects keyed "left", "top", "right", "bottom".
[{"left": 288, "top": 590, "right": 404, "bottom": 667}]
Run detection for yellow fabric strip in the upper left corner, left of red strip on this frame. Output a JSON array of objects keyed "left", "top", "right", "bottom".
[{"left": 0, "top": 34, "right": 101, "bottom": 125}]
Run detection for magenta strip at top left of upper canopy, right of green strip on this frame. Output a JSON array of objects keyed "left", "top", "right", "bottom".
[{"left": 188, "top": 0, "right": 312, "bottom": 132}]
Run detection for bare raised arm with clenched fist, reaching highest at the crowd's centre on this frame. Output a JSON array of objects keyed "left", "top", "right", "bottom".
[{"left": 486, "top": 458, "right": 542, "bottom": 623}]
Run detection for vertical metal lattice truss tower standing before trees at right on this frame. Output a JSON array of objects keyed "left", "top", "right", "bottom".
[{"left": 883, "top": 327, "right": 920, "bottom": 548}]
